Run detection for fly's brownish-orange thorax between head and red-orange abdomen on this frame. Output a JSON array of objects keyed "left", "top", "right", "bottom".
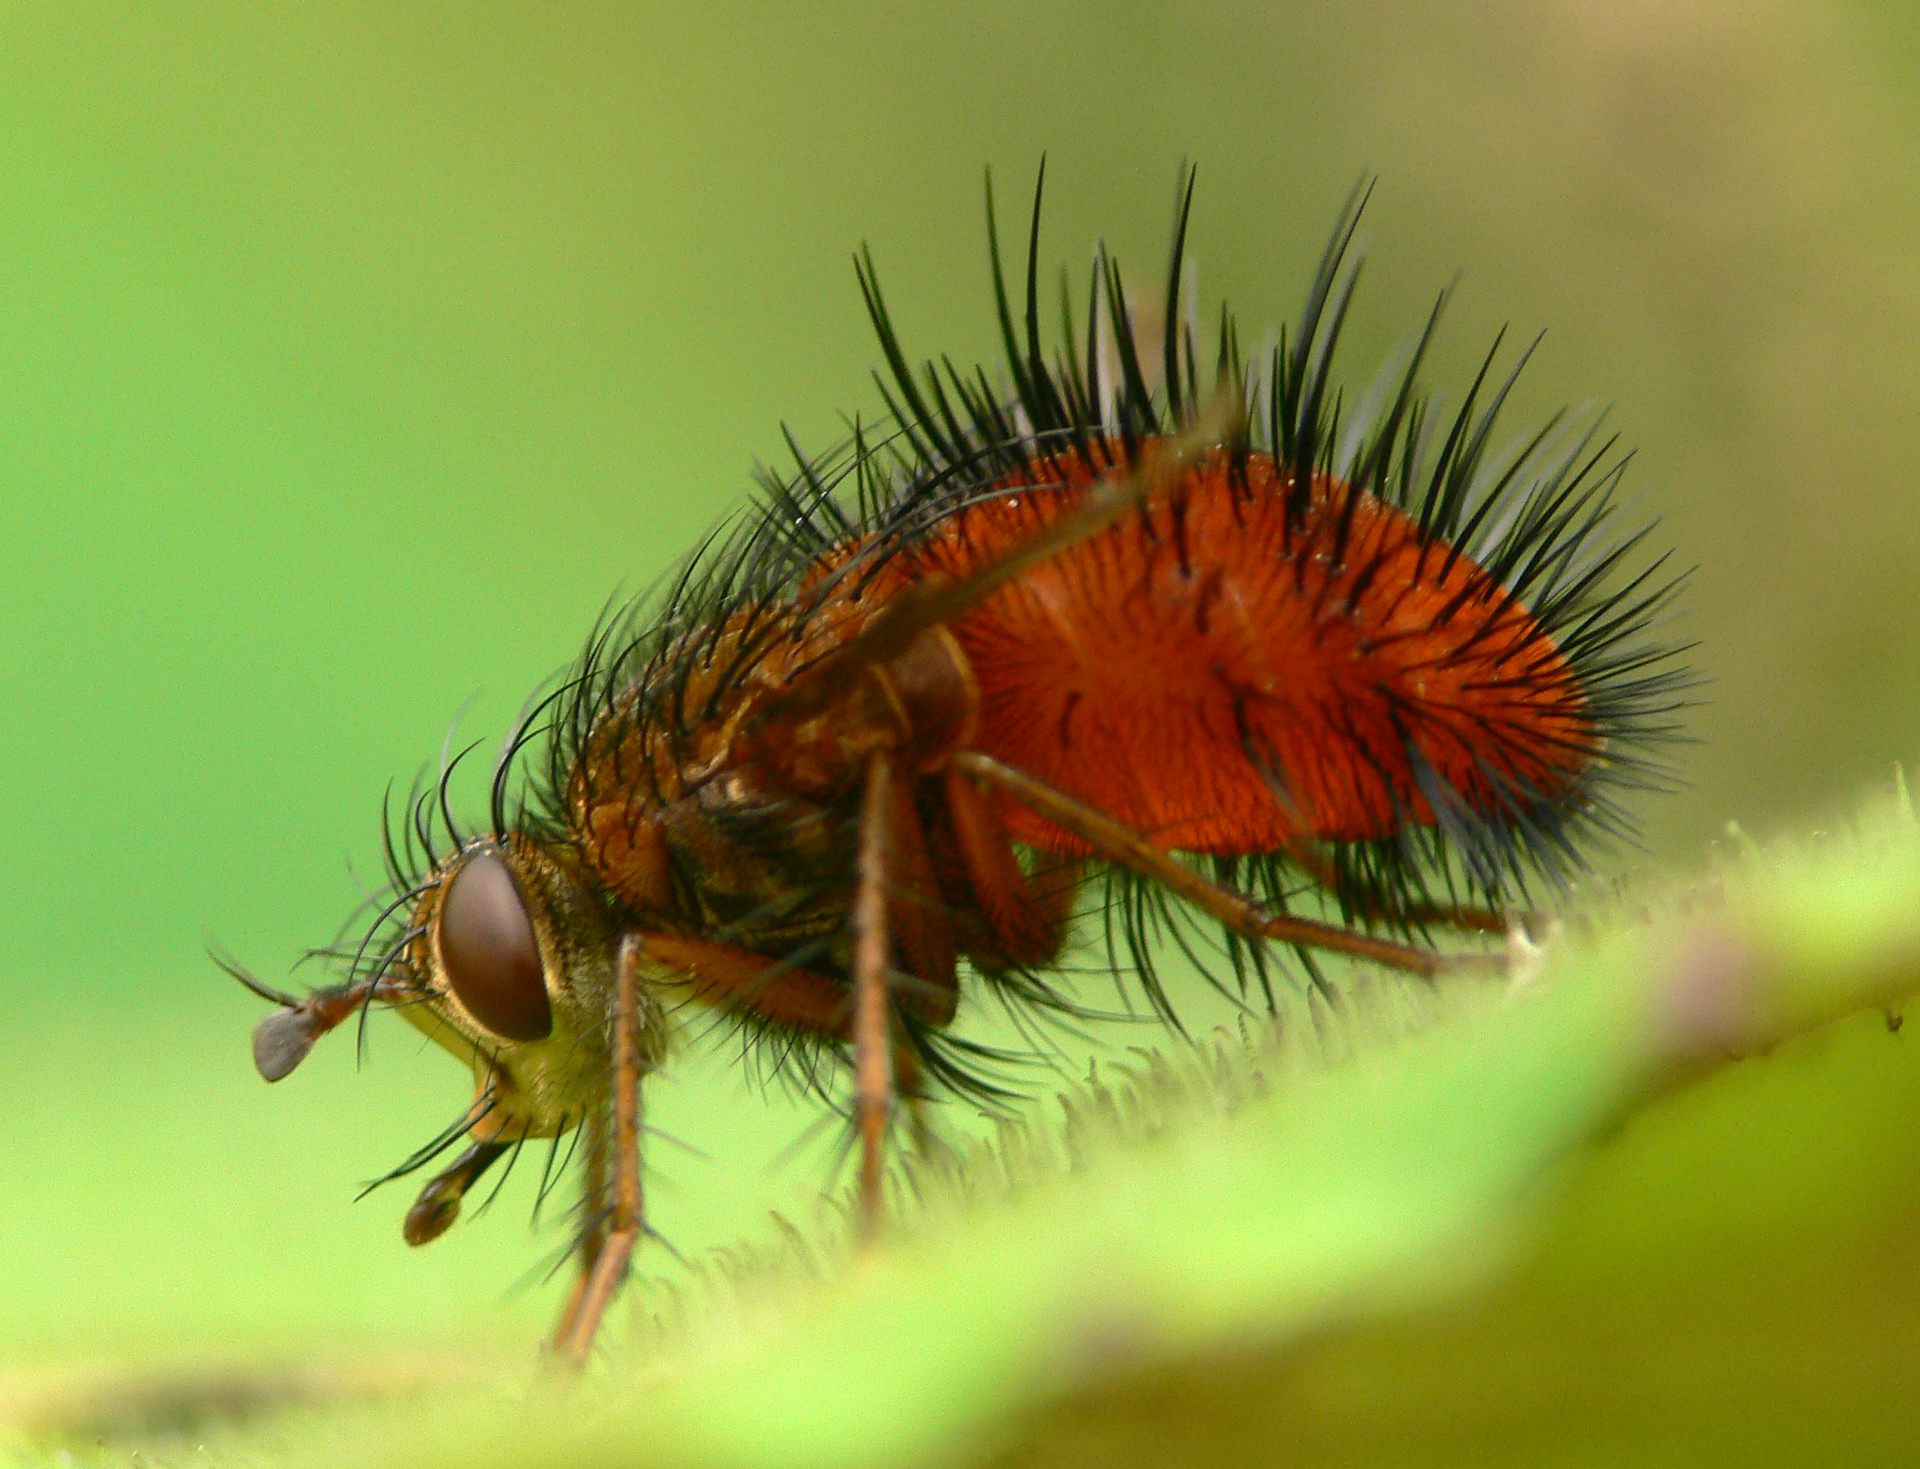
[{"left": 566, "top": 611, "right": 979, "bottom": 933}]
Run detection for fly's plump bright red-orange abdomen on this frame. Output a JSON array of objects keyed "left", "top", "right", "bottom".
[{"left": 881, "top": 453, "right": 1599, "bottom": 855}]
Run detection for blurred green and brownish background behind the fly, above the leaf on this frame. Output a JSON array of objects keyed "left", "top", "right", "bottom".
[{"left": 0, "top": 0, "right": 1920, "bottom": 1365}]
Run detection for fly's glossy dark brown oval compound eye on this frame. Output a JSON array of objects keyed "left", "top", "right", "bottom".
[{"left": 440, "top": 853, "right": 553, "bottom": 1041}]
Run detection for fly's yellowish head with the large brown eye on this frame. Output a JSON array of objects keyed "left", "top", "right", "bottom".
[{"left": 399, "top": 833, "right": 664, "bottom": 1139}]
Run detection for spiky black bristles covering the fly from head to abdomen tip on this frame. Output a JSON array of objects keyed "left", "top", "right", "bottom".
[{"left": 337, "top": 167, "right": 1695, "bottom": 1144}]
